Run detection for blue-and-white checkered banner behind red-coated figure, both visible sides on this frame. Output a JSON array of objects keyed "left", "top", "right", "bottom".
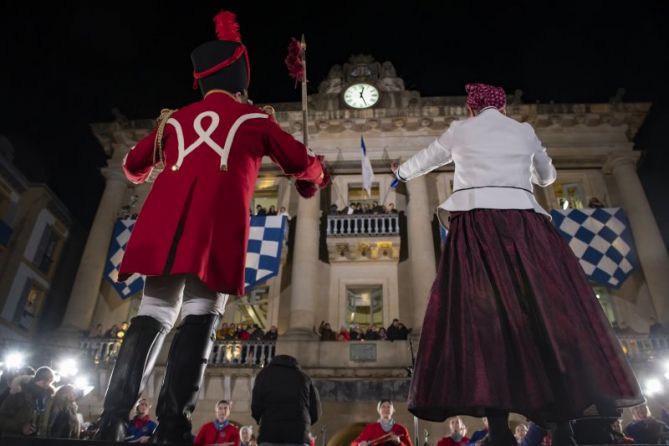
[{"left": 105, "top": 216, "right": 288, "bottom": 299}]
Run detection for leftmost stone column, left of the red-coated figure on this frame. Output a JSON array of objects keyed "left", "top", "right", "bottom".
[{"left": 62, "top": 163, "right": 128, "bottom": 330}]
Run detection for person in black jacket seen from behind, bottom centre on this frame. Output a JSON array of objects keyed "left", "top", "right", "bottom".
[{"left": 251, "top": 355, "right": 321, "bottom": 444}]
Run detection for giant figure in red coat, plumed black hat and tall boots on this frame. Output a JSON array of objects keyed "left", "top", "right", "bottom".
[{"left": 98, "top": 11, "right": 328, "bottom": 444}]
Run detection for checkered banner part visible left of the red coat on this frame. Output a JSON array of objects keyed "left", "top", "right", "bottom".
[{"left": 105, "top": 218, "right": 144, "bottom": 299}]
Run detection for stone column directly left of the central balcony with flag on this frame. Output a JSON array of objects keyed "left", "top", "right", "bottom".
[{"left": 286, "top": 192, "right": 321, "bottom": 339}]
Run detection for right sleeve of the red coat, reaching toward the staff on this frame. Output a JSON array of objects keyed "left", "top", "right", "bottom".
[{"left": 266, "top": 118, "right": 323, "bottom": 184}]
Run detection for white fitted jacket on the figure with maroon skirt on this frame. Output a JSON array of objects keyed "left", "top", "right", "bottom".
[{"left": 397, "top": 108, "right": 557, "bottom": 217}]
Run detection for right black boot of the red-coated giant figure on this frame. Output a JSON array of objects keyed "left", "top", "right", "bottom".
[{"left": 156, "top": 314, "right": 219, "bottom": 444}]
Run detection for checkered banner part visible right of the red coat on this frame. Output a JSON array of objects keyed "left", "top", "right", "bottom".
[{"left": 244, "top": 215, "right": 288, "bottom": 289}]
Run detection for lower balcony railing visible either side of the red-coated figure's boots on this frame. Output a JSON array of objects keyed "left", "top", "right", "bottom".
[{"left": 81, "top": 338, "right": 276, "bottom": 367}]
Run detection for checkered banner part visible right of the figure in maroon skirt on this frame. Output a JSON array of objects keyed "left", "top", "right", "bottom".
[{"left": 551, "top": 208, "right": 639, "bottom": 288}]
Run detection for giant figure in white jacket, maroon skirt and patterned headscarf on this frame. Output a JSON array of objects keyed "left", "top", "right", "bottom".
[{"left": 392, "top": 84, "right": 644, "bottom": 446}]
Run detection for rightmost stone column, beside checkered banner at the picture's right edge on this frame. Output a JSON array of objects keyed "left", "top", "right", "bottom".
[{"left": 604, "top": 152, "right": 669, "bottom": 324}]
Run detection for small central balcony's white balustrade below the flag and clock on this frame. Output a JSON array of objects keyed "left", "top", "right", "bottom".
[{"left": 327, "top": 214, "right": 400, "bottom": 237}]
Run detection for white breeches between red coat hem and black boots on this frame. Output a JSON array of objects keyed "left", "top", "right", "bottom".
[{"left": 137, "top": 274, "right": 228, "bottom": 330}]
